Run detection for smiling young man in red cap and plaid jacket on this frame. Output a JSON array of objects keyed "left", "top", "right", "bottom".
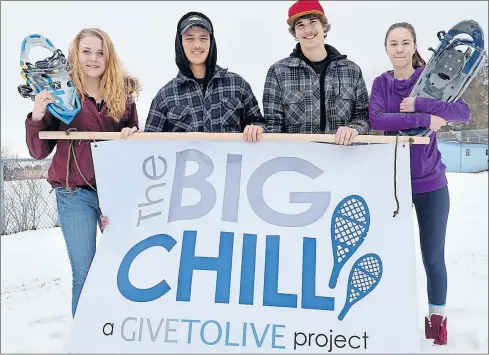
[{"left": 263, "top": 0, "right": 370, "bottom": 145}]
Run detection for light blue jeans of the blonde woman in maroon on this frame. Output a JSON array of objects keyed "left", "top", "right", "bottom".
[{"left": 55, "top": 187, "right": 100, "bottom": 317}]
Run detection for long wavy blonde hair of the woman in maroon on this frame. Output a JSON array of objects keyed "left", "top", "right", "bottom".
[{"left": 68, "top": 28, "right": 141, "bottom": 122}]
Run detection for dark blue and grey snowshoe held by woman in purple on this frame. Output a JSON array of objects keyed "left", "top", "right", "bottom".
[{"left": 400, "top": 20, "right": 487, "bottom": 136}]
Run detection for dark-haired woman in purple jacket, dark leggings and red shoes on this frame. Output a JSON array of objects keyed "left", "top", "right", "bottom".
[{"left": 369, "top": 23, "right": 470, "bottom": 345}]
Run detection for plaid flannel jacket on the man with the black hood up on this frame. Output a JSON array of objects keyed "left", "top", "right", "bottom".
[{"left": 144, "top": 67, "right": 265, "bottom": 133}]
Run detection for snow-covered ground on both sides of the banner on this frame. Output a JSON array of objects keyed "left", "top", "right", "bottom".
[{"left": 1, "top": 172, "right": 488, "bottom": 354}]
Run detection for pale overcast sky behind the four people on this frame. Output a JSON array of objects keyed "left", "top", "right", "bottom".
[{"left": 1, "top": 1, "right": 488, "bottom": 157}]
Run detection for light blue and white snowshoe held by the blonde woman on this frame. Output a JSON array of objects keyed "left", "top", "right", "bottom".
[{"left": 17, "top": 34, "right": 81, "bottom": 124}]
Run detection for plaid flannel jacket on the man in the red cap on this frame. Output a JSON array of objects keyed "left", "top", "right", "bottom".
[{"left": 263, "top": 57, "right": 370, "bottom": 134}]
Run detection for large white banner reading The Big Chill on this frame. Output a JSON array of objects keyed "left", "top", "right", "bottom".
[{"left": 67, "top": 141, "right": 420, "bottom": 353}]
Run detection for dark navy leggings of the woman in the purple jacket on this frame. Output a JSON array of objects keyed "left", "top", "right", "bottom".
[{"left": 413, "top": 186, "right": 450, "bottom": 305}]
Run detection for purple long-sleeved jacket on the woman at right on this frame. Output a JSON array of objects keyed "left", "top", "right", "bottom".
[{"left": 369, "top": 67, "right": 470, "bottom": 194}]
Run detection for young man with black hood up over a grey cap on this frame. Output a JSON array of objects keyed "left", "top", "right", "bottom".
[{"left": 144, "top": 12, "right": 265, "bottom": 142}]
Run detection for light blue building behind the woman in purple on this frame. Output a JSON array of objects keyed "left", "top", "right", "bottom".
[{"left": 438, "top": 140, "right": 489, "bottom": 173}]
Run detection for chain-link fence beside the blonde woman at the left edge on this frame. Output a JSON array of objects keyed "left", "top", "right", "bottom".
[{"left": 0, "top": 158, "right": 59, "bottom": 235}]
